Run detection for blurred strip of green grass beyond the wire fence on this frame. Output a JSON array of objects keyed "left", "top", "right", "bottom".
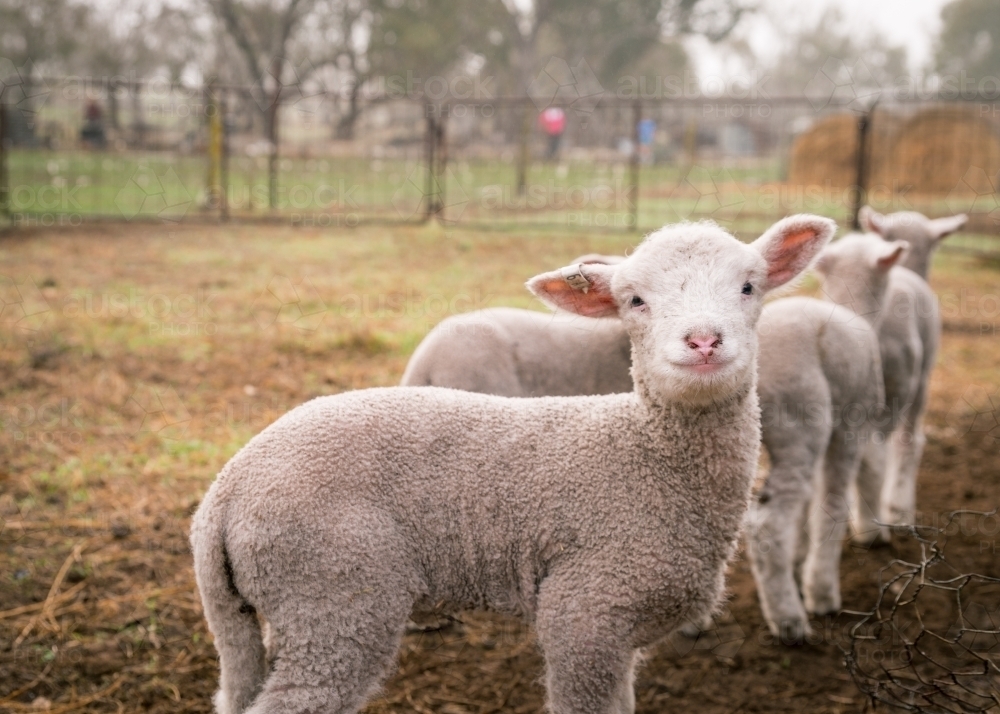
[{"left": 9, "top": 145, "right": 997, "bottom": 239}]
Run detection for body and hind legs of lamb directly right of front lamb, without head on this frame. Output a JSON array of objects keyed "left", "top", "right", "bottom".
[{"left": 747, "top": 297, "right": 883, "bottom": 644}]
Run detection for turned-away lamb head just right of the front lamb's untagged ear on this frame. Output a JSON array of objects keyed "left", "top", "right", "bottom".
[{"left": 816, "top": 233, "right": 908, "bottom": 325}]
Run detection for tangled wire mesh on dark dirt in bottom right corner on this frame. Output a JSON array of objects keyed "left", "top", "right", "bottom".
[{"left": 844, "top": 510, "right": 1000, "bottom": 714}]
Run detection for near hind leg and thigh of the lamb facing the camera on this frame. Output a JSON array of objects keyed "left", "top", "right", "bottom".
[{"left": 247, "top": 514, "right": 417, "bottom": 714}]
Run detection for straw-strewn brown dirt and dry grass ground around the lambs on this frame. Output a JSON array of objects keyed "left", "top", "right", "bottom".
[{"left": 0, "top": 220, "right": 1000, "bottom": 714}]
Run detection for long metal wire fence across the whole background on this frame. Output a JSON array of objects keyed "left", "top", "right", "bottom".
[{"left": 0, "top": 78, "right": 1000, "bottom": 247}]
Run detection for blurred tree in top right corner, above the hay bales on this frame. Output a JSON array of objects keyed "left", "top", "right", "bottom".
[{"left": 934, "top": 0, "right": 1000, "bottom": 79}]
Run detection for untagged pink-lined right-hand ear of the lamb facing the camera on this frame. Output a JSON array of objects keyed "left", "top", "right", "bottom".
[{"left": 752, "top": 213, "right": 837, "bottom": 292}]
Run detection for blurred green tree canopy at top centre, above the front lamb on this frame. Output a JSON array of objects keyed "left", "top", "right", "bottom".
[{"left": 371, "top": 0, "right": 747, "bottom": 96}]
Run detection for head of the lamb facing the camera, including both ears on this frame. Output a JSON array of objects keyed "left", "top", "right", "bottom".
[{"left": 528, "top": 216, "right": 836, "bottom": 406}]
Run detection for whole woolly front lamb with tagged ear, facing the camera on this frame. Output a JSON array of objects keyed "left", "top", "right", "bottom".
[{"left": 191, "top": 216, "right": 834, "bottom": 714}]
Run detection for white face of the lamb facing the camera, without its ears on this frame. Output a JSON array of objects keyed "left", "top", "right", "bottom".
[{"left": 611, "top": 225, "right": 767, "bottom": 404}]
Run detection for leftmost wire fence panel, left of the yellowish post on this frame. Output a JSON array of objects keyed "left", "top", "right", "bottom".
[{"left": 5, "top": 80, "right": 205, "bottom": 224}]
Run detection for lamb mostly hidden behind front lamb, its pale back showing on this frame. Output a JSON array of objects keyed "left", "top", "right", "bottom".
[{"left": 400, "top": 254, "right": 632, "bottom": 397}]
